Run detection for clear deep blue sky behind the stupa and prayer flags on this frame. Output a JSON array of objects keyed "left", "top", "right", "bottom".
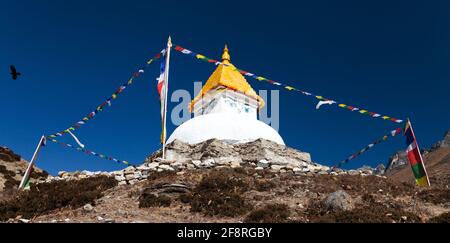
[{"left": 0, "top": 0, "right": 450, "bottom": 173}]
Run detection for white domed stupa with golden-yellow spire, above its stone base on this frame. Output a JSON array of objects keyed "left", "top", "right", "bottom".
[{"left": 167, "top": 46, "right": 284, "bottom": 145}]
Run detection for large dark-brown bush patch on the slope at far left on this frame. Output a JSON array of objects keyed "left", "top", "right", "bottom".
[{"left": 0, "top": 176, "right": 117, "bottom": 221}]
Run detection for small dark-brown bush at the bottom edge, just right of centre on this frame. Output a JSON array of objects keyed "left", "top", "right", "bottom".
[{"left": 244, "top": 204, "right": 290, "bottom": 223}]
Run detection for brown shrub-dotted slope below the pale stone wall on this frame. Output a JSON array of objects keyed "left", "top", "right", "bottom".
[{"left": 4, "top": 167, "right": 450, "bottom": 223}]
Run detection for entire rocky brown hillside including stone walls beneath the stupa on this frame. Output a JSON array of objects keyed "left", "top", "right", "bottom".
[{"left": 0, "top": 135, "right": 450, "bottom": 223}]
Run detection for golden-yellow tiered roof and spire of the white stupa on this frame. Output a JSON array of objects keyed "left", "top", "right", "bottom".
[{"left": 190, "top": 46, "right": 264, "bottom": 110}]
